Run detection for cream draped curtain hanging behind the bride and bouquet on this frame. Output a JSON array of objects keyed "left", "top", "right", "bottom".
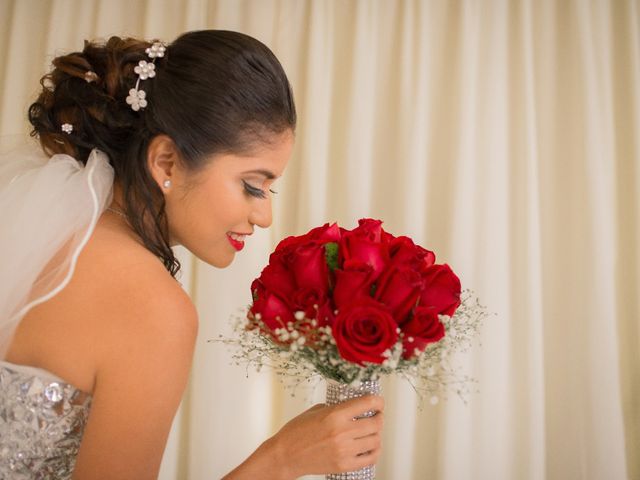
[{"left": 0, "top": 0, "right": 640, "bottom": 480}]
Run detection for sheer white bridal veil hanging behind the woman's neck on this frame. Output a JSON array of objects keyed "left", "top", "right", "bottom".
[{"left": 0, "top": 141, "right": 113, "bottom": 360}]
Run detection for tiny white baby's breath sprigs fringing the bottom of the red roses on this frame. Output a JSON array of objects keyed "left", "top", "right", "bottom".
[{"left": 214, "top": 292, "right": 487, "bottom": 405}]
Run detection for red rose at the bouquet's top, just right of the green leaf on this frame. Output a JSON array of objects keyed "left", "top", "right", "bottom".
[{"left": 338, "top": 219, "right": 389, "bottom": 279}]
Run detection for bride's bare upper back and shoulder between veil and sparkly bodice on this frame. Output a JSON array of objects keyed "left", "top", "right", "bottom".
[{"left": 7, "top": 216, "right": 198, "bottom": 392}]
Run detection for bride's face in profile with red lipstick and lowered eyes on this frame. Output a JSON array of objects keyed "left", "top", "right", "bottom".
[{"left": 165, "top": 131, "right": 293, "bottom": 268}]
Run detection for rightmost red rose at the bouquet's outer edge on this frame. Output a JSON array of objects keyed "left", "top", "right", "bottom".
[{"left": 420, "top": 264, "right": 461, "bottom": 316}]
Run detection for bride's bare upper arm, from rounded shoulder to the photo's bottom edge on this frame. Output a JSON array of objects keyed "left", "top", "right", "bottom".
[{"left": 73, "top": 272, "right": 197, "bottom": 480}]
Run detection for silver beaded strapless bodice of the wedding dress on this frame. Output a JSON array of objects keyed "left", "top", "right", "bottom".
[{"left": 0, "top": 361, "right": 91, "bottom": 480}]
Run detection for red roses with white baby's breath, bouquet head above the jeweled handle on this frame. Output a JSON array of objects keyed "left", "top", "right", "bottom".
[{"left": 222, "top": 219, "right": 486, "bottom": 404}]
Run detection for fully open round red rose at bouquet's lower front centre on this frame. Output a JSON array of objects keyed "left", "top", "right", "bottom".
[{"left": 332, "top": 297, "right": 398, "bottom": 365}]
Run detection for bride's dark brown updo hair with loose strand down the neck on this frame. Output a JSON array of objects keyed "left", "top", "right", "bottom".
[{"left": 29, "top": 30, "right": 296, "bottom": 276}]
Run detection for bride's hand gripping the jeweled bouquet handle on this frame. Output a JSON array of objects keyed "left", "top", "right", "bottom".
[{"left": 270, "top": 395, "right": 384, "bottom": 478}]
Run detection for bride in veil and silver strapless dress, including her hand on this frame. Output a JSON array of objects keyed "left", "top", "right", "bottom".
[{"left": 0, "top": 30, "right": 383, "bottom": 480}]
